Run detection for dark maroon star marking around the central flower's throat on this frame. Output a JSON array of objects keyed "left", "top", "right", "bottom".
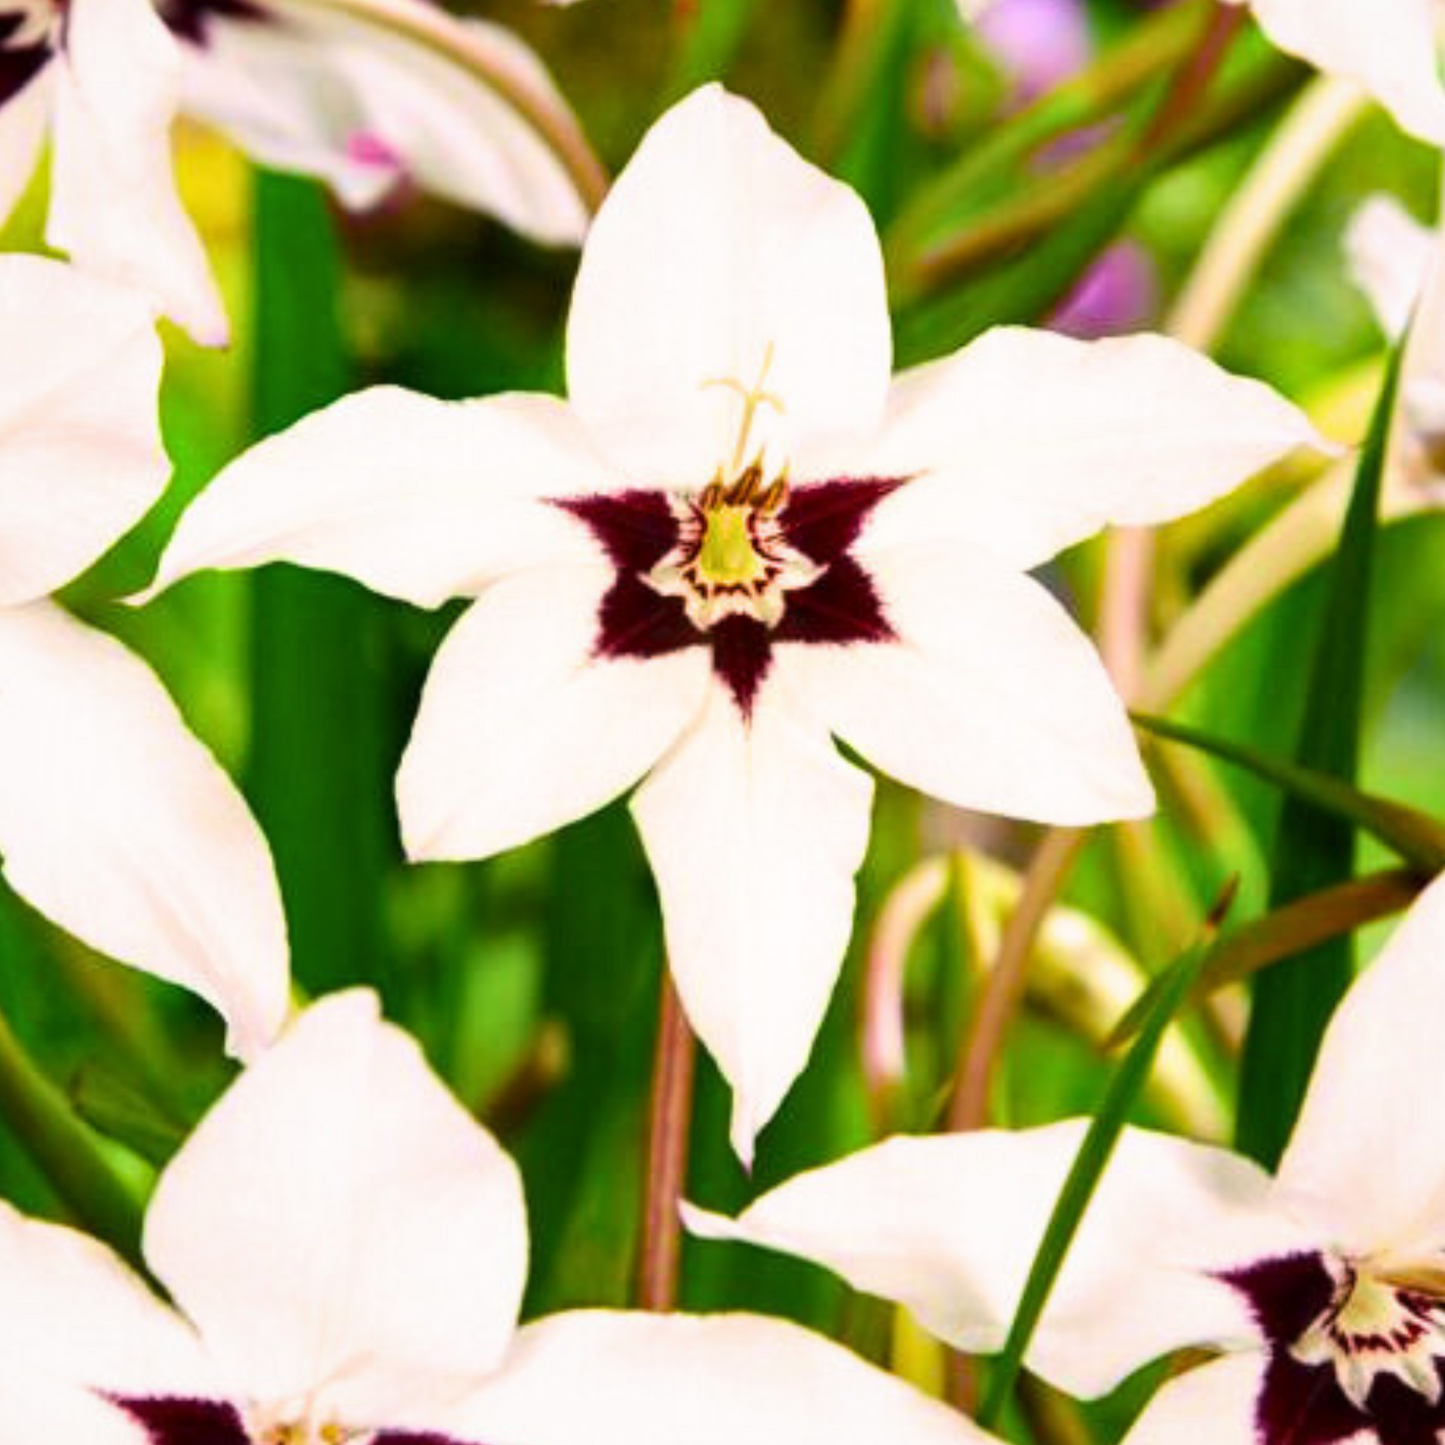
[{"left": 558, "top": 477, "right": 903, "bottom": 715}]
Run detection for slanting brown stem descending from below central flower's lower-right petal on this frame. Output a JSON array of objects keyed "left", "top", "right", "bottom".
[{"left": 948, "top": 828, "right": 1085, "bottom": 1130}]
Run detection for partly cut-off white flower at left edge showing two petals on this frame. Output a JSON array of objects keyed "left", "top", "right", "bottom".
[{"left": 0, "top": 256, "right": 288, "bottom": 1056}]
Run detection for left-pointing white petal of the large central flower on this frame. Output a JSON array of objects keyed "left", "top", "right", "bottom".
[{"left": 152, "top": 386, "right": 610, "bottom": 607}]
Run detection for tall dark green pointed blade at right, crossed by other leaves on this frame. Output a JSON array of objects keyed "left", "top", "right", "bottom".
[{"left": 1235, "top": 341, "right": 1404, "bottom": 1168}]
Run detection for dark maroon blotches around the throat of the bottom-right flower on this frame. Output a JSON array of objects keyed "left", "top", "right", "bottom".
[{"left": 1221, "top": 1254, "right": 1445, "bottom": 1445}]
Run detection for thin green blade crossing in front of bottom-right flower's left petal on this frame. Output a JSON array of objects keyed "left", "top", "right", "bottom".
[{"left": 978, "top": 887, "right": 1233, "bottom": 1429}]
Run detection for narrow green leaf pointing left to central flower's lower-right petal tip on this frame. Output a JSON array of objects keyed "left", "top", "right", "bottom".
[{"left": 1131, "top": 712, "right": 1445, "bottom": 873}]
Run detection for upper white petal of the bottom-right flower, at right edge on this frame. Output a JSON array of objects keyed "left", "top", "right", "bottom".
[{"left": 1279, "top": 880, "right": 1445, "bottom": 1254}]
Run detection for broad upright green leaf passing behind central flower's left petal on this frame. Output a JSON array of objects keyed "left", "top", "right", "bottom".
[{"left": 246, "top": 173, "right": 405, "bottom": 993}]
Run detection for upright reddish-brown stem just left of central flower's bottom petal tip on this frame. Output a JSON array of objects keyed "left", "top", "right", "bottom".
[{"left": 637, "top": 970, "right": 696, "bottom": 1311}]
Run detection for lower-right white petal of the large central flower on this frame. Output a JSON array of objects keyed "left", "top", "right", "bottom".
[{"left": 785, "top": 548, "right": 1153, "bottom": 824}]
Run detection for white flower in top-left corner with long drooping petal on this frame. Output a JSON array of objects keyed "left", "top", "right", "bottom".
[{"left": 0, "top": 0, "right": 228, "bottom": 345}]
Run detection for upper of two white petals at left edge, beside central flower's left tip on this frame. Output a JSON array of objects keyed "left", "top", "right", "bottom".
[{"left": 0, "top": 256, "right": 171, "bottom": 605}]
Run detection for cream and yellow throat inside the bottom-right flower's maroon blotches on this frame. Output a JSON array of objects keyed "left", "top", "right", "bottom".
[{"left": 1289, "top": 1261, "right": 1445, "bottom": 1410}]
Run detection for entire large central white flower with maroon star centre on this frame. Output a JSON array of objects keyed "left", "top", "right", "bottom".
[{"left": 143, "top": 87, "right": 1314, "bottom": 1156}]
